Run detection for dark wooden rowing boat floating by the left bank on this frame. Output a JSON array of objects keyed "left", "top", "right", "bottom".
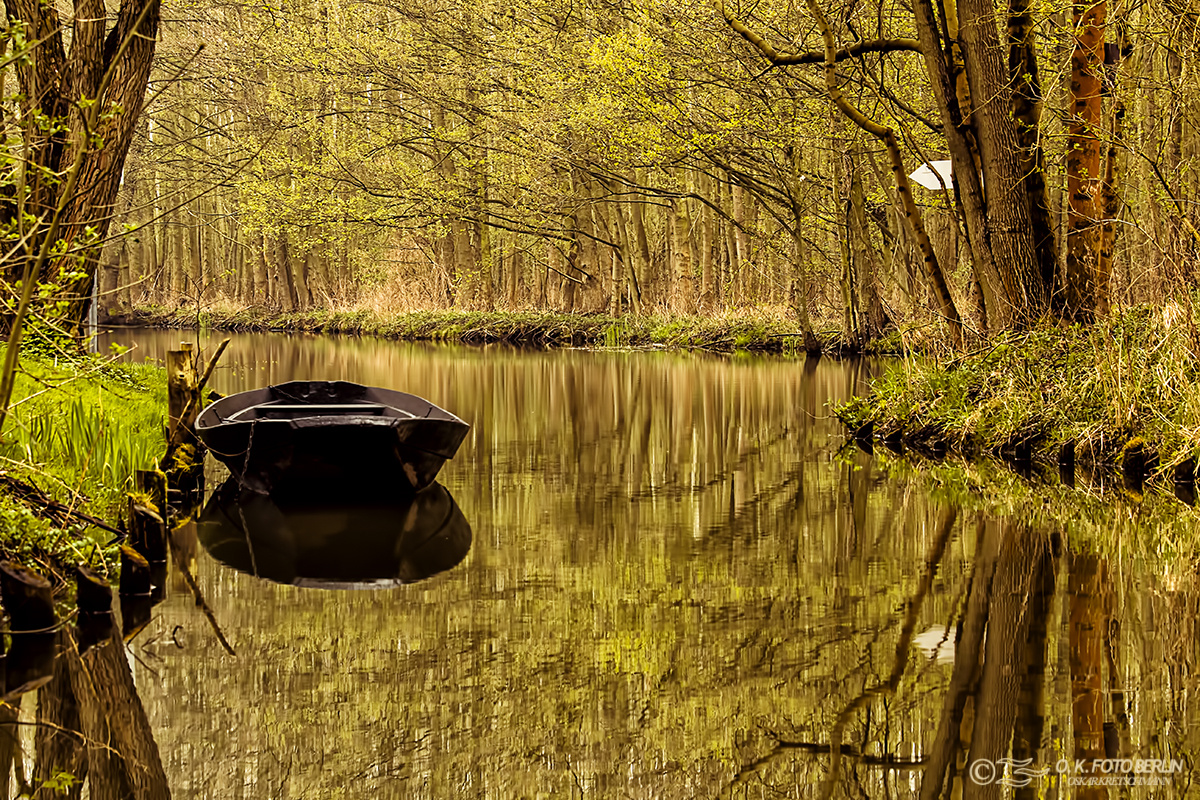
[{"left": 196, "top": 380, "right": 470, "bottom": 497}]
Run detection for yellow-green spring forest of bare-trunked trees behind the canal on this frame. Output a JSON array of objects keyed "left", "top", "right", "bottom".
[{"left": 4, "top": 0, "right": 1200, "bottom": 350}]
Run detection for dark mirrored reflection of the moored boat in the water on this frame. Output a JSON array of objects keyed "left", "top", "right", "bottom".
[{"left": 197, "top": 479, "right": 470, "bottom": 589}]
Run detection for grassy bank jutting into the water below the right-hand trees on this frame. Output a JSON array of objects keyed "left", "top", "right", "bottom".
[{"left": 836, "top": 305, "right": 1200, "bottom": 471}]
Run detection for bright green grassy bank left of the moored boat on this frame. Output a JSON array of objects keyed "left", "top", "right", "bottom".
[{"left": 0, "top": 348, "right": 167, "bottom": 567}]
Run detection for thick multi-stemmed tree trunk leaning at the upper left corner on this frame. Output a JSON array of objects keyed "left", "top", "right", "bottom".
[{"left": 0, "top": 0, "right": 161, "bottom": 425}]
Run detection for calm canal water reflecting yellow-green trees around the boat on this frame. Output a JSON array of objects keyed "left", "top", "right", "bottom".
[{"left": 42, "top": 331, "right": 1200, "bottom": 800}]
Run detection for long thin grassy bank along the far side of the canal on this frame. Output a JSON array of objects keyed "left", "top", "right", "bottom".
[{"left": 119, "top": 306, "right": 899, "bottom": 353}]
